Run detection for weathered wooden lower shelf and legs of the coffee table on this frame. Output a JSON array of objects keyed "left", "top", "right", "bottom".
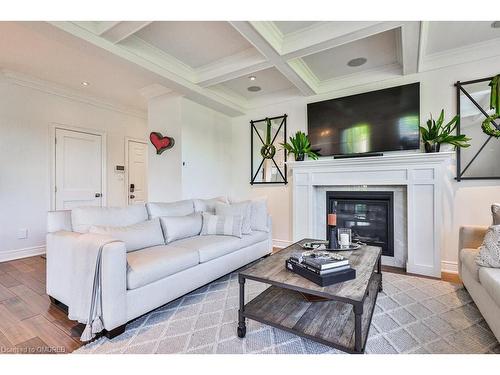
[{"left": 238, "top": 273, "right": 382, "bottom": 353}]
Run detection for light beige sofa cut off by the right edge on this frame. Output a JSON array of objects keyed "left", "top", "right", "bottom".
[{"left": 458, "top": 226, "right": 500, "bottom": 341}]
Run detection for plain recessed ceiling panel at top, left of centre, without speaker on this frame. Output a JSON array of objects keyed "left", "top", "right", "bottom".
[{"left": 135, "top": 21, "right": 253, "bottom": 68}]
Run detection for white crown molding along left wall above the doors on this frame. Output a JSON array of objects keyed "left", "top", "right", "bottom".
[{"left": 0, "top": 69, "right": 147, "bottom": 120}]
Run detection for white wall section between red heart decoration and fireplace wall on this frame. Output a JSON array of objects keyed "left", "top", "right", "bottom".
[{"left": 148, "top": 95, "right": 233, "bottom": 202}]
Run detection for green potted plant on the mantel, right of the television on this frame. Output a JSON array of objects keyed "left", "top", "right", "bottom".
[{"left": 420, "top": 109, "right": 471, "bottom": 152}]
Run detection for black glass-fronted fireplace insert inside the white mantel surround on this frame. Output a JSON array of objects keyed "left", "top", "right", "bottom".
[{"left": 326, "top": 191, "right": 394, "bottom": 257}]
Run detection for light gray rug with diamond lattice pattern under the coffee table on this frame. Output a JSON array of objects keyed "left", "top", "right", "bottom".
[{"left": 75, "top": 273, "right": 500, "bottom": 354}]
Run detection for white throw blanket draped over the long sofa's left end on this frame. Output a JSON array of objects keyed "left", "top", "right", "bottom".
[{"left": 68, "top": 233, "right": 119, "bottom": 341}]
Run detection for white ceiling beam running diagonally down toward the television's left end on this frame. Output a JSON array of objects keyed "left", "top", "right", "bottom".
[{"left": 230, "top": 21, "right": 316, "bottom": 96}]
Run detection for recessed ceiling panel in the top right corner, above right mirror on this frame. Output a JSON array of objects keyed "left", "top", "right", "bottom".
[{"left": 425, "top": 21, "right": 500, "bottom": 54}]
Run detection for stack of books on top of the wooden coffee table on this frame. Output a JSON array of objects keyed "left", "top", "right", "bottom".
[{"left": 286, "top": 251, "right": 356, "bottom": 286}]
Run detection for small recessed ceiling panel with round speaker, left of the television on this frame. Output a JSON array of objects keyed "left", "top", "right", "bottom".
[{"left": 215, "top": 68, "right": 299, "bottom": 99}]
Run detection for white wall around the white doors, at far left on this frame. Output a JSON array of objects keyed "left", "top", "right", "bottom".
[{"left": 0, "top": 78, "right": 146, "bottom": 261}]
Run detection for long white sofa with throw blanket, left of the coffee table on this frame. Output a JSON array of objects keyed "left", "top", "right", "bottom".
[{"left": 47, "top": 200, "right": 272, "bottom": 337}]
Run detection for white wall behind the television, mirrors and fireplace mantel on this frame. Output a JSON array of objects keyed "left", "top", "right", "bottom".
[{"left": 232, "top": 58, "right": 500, "bottom": 271}]
